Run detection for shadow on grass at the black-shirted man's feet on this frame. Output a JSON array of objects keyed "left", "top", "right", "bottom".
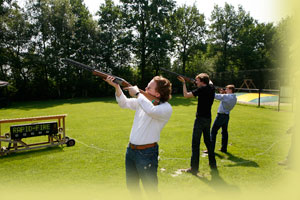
[{"left": 195, "top": 169, "right": 240, "bottom": 192}]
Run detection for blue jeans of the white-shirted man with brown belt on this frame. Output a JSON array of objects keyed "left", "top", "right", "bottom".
[{"left": 125, "top": 145, "right": 158, "bottom": 193}]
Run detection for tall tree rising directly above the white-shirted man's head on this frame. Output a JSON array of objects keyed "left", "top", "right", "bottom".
[{"left": 120, "top": 0, "right": 175, "bottom": 87}]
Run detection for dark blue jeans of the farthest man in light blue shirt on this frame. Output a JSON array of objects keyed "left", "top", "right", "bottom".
[{"left": 210, "top": 113, "right": 229, "bottom": 152}]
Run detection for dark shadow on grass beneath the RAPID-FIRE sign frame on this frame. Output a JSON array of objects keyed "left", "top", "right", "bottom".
[{"left": 0, "top": 146, "right": 64, "bottom": 163}]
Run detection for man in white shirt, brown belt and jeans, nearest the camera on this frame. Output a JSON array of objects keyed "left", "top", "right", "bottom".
[{"left": 106, "top": 76, "right": 172, "bottom": 194}]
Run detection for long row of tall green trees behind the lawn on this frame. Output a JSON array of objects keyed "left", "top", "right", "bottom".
[{"left": 0, "top": 0, "right": 290, "bottom": 100}]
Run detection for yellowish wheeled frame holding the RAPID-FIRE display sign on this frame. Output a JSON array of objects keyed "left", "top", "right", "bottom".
[{"left": 0, "top": 114, "right": 75, "bottom": 155}]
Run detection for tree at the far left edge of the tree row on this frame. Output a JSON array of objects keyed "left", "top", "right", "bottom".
[{"left": 0, "top": 1, "right": 32, "bottom": 99}]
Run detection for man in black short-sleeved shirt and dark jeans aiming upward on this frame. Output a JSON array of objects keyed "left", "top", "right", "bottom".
[{"left": 178, "top": 73, "right": 217, "bottom": 175}]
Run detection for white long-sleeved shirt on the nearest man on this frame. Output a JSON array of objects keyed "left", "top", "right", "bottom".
[{"left": 116, "top": 92, "right": 172, "bottom": 145}]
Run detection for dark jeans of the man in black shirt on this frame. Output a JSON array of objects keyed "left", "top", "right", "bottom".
[{"left": 191, "top": 117, "right": 216, "bottom": 172}]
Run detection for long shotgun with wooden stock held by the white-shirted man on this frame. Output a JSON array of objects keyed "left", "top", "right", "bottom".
[{"left": 61, "top": 58, "right": 160, "bottom": 106}]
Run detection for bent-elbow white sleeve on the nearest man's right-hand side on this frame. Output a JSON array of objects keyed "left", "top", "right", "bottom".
[{"left": 137, "top": 94, "right": 172, "bottom": 121}]
